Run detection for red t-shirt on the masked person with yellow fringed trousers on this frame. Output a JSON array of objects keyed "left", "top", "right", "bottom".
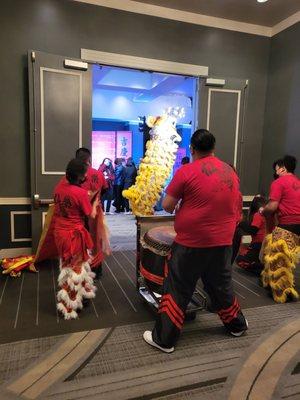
[{"left": 270, "top": 174, "right": 300, "bottom": 225}]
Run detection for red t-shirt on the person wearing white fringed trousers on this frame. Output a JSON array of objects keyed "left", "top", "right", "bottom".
[{"left": 54, "top": 179, "right": 92, "bottom": 225}]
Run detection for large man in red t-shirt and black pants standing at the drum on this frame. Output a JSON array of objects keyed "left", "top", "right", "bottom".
[{"left": 143, "top": 129, "right": 248, "bottom": 353}]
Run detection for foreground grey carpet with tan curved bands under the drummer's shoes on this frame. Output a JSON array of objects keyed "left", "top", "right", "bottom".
[{"left": 0, "top": 303, "right": 300, "bottom": 400}]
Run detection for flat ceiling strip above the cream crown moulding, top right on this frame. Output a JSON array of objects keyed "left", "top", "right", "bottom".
[{"left": 137, "top": 0, "right": 300, "bottom": 27}]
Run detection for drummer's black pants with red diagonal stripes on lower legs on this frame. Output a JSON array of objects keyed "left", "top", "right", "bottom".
[{"left": 152, "top": 243, "right": 246, "bottom": 348}]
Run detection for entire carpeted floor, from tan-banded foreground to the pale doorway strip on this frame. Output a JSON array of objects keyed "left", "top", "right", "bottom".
[{"left": 0, "top": 215, "right": 300, "bottom": 400}]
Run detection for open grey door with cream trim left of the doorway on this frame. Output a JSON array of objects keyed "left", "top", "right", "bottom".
[{"left": 28, "top": 51, "right": 92, "bottom": 252}]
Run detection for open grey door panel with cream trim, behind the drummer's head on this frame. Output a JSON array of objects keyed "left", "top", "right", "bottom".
[{"left": 198, "top": 79, "right": 248, "bottom": 175}]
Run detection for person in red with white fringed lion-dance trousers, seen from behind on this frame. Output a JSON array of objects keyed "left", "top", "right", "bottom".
[{"left": 54, "top": 158, "right": 99, "bottom": 319}]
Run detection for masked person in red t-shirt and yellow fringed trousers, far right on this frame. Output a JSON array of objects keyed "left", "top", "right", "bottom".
[{"left": 260, "top": 155, "right": 300, "bottom": 303}]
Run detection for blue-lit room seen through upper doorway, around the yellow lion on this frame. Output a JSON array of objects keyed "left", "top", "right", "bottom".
[{"left": 92, "top": 65, "right": 198, "bottom": 169}]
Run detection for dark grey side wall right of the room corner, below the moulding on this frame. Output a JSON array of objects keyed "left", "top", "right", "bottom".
[{"left": 260, "top": 23, "right": 300, "bottom": 193}]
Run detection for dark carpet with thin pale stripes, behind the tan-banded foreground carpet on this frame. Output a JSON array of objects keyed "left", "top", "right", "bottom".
[{"left": 0, "top": 250, "right": 299, "bottom": 343}]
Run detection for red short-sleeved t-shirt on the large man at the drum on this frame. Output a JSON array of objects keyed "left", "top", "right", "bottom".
[{"left": 166, "top": 156, "right": 241, "bottom": 248}]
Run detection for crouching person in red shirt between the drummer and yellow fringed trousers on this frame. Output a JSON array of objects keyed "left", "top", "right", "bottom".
[{"left": 235, "top": 195, "right": 267, "bottom": 274}]
